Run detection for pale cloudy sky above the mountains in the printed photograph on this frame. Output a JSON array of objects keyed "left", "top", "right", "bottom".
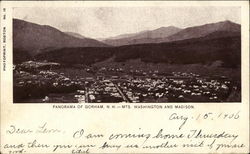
[{"left": 13, "top": 6, "right": 241, "bottom": 38}]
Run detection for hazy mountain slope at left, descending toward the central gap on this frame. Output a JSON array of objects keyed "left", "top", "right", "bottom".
[{"left": 13, "top": 19, "right": 108, "bottom": 55}]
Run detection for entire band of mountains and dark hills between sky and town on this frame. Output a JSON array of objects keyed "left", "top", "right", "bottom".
[{"left": 13, "top": 19, "right": 241, "bottom": 68}]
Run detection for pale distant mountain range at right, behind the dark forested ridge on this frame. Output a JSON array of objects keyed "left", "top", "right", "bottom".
[{"left": 103, "top": 20, "right": 241, "bottom": 46}]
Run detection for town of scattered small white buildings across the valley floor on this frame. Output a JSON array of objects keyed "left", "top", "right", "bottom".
[{"left": 13, "top": 61, "right": 239, "bottom": 103}]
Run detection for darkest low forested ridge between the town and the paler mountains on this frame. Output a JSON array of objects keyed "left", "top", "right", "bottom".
[{"left": 35, "top": 36, "right": 241, "bottom": 68}]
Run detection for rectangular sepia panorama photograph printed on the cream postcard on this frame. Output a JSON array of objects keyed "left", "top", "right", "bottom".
[{"left": 12, "top": 6, "right": 241, "bottom": 103}]
